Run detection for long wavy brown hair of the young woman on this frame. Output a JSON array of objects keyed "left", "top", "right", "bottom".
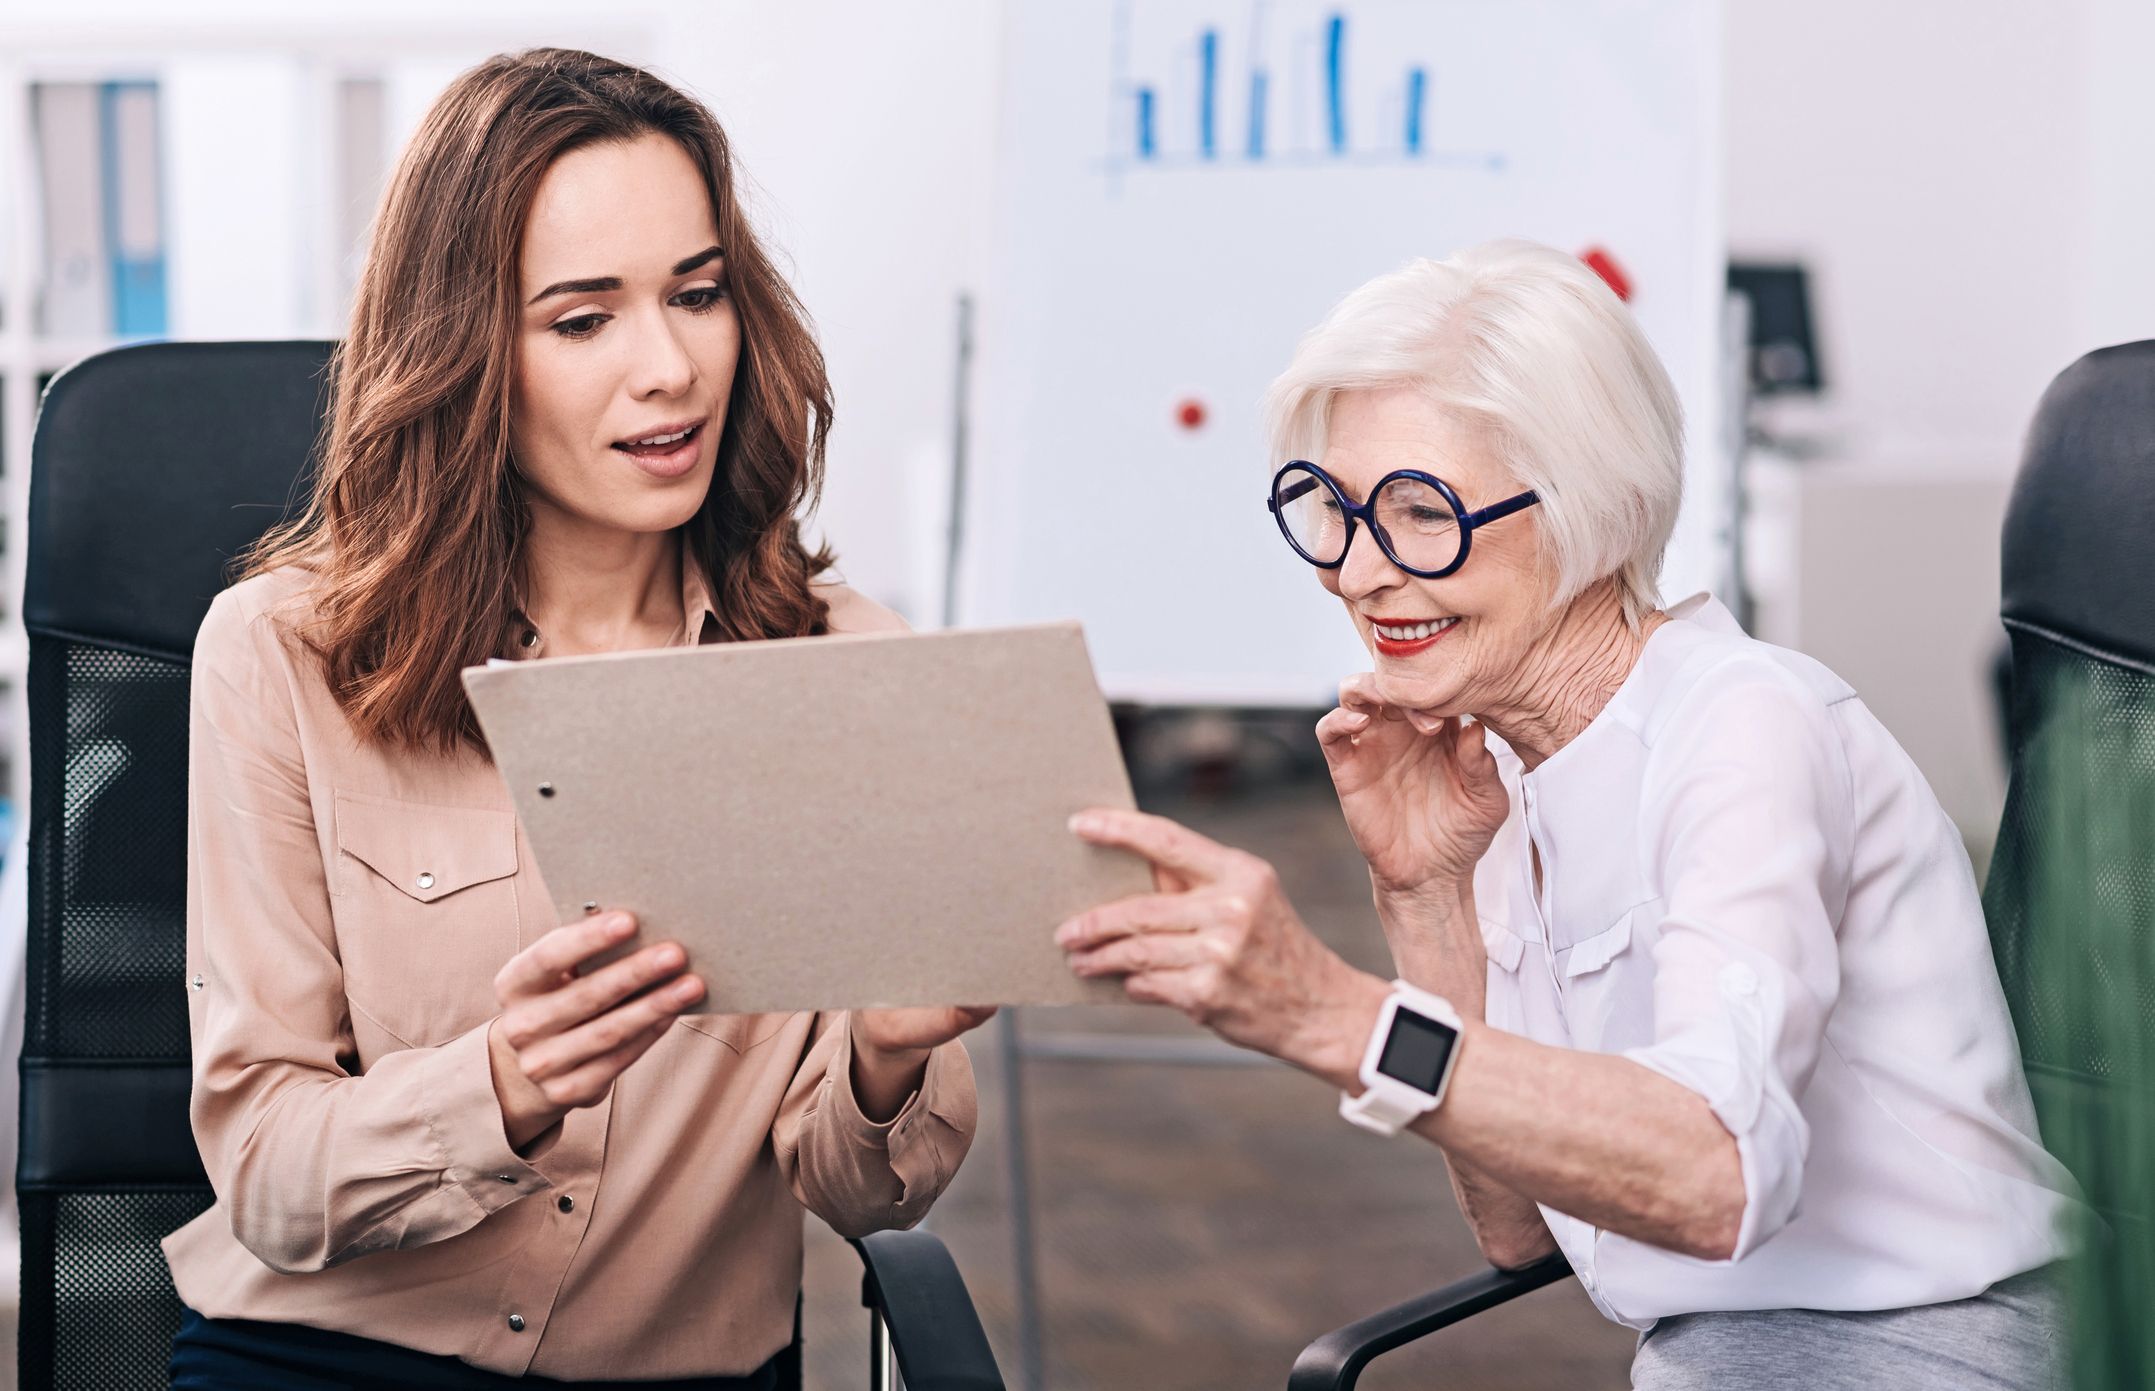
[{"left": 241, "top": 47, "right": 832, "bottom": 753}]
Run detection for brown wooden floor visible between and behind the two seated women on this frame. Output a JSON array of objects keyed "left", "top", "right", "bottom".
[{"left": 806, "top": 774, "right": 1631, "bottom": 1391}]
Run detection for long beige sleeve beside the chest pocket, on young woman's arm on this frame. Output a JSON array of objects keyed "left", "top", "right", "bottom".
[{"left": 187, "top": 593, "right": 545, "bottom": 1272}]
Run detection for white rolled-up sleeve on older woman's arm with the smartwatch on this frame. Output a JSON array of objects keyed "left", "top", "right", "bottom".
[{"left": 1625, "top": 662, "right": 1855, "bottom": 1259}]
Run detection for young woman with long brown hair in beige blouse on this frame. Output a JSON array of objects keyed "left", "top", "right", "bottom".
[{"left": 166, "top": 50, "right": 989, "bottom": 1389}]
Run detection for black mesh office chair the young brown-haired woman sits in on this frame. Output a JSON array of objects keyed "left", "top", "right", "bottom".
[{"left": 15, "top": 343, "right": 1002, "bottom": 1391}]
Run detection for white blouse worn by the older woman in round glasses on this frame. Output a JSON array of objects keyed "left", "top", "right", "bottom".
[{"left": 1474, "top": 595, "right": 2077, "bottom": 1328}]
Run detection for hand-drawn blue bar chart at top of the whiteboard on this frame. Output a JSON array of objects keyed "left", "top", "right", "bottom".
[{"left": 1103, "top": 0, "right": 1504, "bottom": 175}]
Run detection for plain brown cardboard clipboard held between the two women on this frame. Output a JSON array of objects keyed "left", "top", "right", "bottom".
[{"left": 463, "top": 623, "right": 1153, "bottom": 1014}]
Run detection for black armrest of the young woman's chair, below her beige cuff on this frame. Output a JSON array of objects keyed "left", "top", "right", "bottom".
[{"left": 849, "top": 1229, "right": 1004, "bottom": 1391}]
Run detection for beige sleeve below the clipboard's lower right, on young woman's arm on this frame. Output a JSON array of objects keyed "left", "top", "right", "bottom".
[{"left": 771, "top": 1011, "right": 978, "bottom": 1236}]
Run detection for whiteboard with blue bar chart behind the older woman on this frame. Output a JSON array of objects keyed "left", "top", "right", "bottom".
[{"left": 959, "top": 0, "right": 1726, "bottom": 705}]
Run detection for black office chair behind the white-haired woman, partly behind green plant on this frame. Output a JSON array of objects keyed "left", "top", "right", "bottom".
[{"left": 1983, "top": 341, "right": 2155, "bottom": 1387}]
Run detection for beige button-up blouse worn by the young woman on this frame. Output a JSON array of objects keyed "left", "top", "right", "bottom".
[{"left": 164, "top": 571, "right": 976, "bottom": 1380}]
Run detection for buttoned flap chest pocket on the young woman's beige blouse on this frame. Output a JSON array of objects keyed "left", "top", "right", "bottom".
[{"left": 332, "top": 794, "right": 522, "bottom": 1061}]
